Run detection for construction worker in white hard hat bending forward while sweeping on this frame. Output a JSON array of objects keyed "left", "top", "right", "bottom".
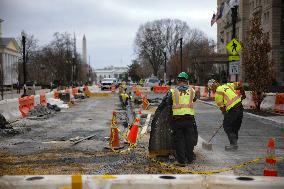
[{"left": 208, "top": 79, "right": 246, "bottom": 151}]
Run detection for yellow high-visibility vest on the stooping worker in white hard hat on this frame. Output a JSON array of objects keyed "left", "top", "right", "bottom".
[{"left": 215, "top": 83, "right": 241, "bottom": 111}]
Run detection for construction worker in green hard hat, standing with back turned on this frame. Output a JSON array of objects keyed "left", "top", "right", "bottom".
[{"left": 157, "top": 72, "right": 198, "bottom": 167}]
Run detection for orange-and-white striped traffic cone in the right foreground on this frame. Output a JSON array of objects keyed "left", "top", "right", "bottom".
[{"left": 263, "top": 138, "right": 278, "bottom": 177}]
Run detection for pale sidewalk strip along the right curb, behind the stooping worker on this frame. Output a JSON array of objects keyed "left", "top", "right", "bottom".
[{"left": 199, "top": 100, "right": 284, "bottom": 128}]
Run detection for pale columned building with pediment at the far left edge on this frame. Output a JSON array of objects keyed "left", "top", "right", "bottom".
[{"left": 0, "top": 19, "right": 21, "bottom": 85}]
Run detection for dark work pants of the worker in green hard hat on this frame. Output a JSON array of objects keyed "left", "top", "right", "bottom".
[{"left": 171, "top": 118, "right": 197, "bottom": 164}]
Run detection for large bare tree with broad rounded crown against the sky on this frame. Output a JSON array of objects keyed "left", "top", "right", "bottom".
[{"left": 135, "top": 19, "right": 189, "bottom": 76}]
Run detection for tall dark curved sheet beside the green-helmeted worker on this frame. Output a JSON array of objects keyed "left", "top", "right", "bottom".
[{"left": 149, "top": 107, "right": 175, "bottom": 157}]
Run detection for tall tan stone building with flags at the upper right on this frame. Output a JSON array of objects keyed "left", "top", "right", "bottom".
[{"left": 217, "top": 0, "right": 284, "bottom": 85}]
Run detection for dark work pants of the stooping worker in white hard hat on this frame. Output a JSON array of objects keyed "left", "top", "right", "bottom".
[{"left": 223, "top": 105, "right": 244, "bottom": 145}]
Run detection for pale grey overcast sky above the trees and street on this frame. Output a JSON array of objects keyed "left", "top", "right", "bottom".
[{"left": 0, "top": 0, "right": 217, "bottom": 68}]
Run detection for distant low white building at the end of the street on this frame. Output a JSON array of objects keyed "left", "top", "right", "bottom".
[{"left": 95, "top": 66, "right": 128, "bottom": 82}]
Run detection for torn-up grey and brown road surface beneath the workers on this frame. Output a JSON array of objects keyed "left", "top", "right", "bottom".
[{"left": 0, "top": 95, "right": 284, "bottom": 176}]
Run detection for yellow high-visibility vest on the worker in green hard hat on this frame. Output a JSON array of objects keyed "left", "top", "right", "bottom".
[{"left": 171, "top": 88, "right": 195, "bottom": 115}]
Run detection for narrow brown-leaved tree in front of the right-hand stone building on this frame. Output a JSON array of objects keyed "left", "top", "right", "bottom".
[{"left": 243, "top": 17, "right": 274, "bottom": 110}]
